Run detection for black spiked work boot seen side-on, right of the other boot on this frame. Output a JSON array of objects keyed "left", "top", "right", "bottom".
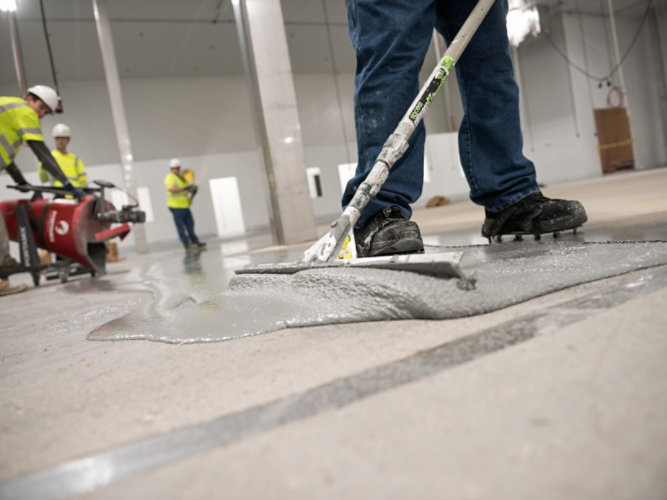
[{"left": 482, "top": 193, "right": 588, "bottom": 243}]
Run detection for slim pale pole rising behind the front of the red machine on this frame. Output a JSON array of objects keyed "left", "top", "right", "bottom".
[{"left": 93, "top": 0, "right": 148, "bottom": 253}]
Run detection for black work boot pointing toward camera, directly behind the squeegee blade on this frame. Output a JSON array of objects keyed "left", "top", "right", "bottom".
[{"left": 354, "top": 206, "right": 424, "bottom": 257}]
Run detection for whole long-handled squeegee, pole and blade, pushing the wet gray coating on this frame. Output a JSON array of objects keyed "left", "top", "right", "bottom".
[{"left": 236, "top": 0, "right": 494, "bottom": 277}]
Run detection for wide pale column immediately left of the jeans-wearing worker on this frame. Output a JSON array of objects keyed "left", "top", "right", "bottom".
[{"left": 232, "top": 0, "right": 317, "bottom": 245}]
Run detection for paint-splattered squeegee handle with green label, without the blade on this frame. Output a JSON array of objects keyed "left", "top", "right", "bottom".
[{"left": 302, "top": 0, "right": 495, "bottom": 262}]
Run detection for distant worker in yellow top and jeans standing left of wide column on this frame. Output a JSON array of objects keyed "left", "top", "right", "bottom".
[{"left": 164, "top": 158, "right": 206, "bottom": 252}]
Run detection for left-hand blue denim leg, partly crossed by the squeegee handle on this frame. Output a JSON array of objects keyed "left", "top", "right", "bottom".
[{"left": 342, "top": 0, "right": 435, "bottom": 227}]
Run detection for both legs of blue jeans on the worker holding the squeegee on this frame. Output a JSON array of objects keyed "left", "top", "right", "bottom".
[{"left": 342, "top": 0, "right": 539, "bottom": 227}]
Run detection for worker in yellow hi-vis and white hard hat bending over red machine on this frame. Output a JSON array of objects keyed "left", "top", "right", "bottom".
[{"left": 0, "top": 85, "right": 84, "bottom": 295}]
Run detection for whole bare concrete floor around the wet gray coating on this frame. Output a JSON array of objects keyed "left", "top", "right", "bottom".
[{"left": 0, "top": 169, "right": 667, "bottom": 500}]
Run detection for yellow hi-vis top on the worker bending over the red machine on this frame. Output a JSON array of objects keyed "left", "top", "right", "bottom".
[{"left": 0, "top": 97, "right": 44, "bottom": 170}]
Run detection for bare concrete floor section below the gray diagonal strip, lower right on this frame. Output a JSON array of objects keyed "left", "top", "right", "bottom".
[{"left": 81, "top": 290, "right": 667, "bottom": 500}]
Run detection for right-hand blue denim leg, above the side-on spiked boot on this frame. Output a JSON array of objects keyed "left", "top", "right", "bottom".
[{"left": 436, "top": 0, "right": 539, "bottom": 212}]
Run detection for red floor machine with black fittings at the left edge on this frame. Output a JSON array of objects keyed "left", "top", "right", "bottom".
[{"left": 0, "top": 181, "right": 146, "bottom": 286}]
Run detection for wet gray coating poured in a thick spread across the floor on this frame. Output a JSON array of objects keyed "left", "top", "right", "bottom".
[{"left": 88, "top": 241, "right": 667, "bottom": 343}]
